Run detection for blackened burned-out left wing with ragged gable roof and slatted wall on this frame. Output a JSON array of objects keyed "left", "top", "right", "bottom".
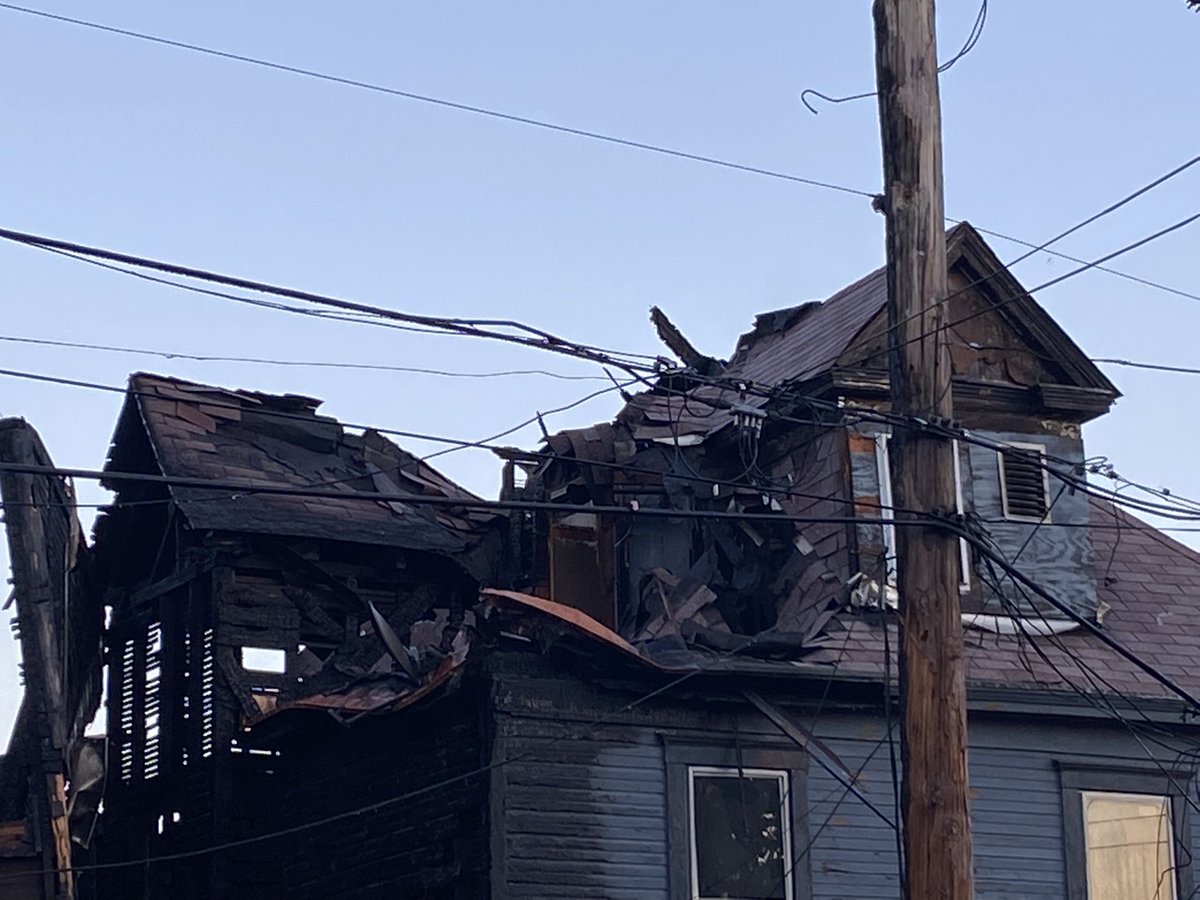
[{"left": 95, "top": 374, "right": 504, "bottom": 898}]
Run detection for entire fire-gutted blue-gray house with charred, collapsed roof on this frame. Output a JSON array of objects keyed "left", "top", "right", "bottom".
[{"left": 0, "top": 226, "right": 1200, "bottom": 900}]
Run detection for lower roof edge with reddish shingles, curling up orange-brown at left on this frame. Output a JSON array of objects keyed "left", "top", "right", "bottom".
[{"left": 484, "top": 500, "right": 1200, "bottom": 701}]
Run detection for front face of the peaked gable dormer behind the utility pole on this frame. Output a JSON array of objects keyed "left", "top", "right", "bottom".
[{"left": 829, "top": 224, "right": 1120, "bottom": 616}]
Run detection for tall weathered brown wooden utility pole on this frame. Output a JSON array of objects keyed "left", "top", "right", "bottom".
[{"left": 875, "top": 0, "right": 972, "bottom": 900}]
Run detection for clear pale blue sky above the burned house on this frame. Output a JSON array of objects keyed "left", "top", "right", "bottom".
[{"left": 0, "top": 0, "right": 1200, "bottom": 740}]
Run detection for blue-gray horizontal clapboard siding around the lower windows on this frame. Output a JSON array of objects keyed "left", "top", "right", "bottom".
[{"left": 493, "top": 672, "right": 1200, "bottom": 900}]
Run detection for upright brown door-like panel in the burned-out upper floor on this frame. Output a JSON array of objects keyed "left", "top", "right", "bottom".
[{"left": 550, "top": 514, "right": 617, "bottom": 629}]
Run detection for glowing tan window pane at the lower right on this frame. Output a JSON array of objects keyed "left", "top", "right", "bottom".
[{"left": 1080, "top": 791, "right": 1176, "bottom": 900}]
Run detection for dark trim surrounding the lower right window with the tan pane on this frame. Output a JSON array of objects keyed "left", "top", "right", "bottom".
[{"left": 1057, "top": 762, "right": 1194, "bottom": 900}]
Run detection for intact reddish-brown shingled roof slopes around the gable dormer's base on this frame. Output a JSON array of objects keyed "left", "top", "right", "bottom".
[{"left": 825, "top": 500, "right": 1200, "bottom": 700}]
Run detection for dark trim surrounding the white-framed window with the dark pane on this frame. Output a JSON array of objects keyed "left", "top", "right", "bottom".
[{"left": 662, "top": 736, "right": 812, "bottom": 900}]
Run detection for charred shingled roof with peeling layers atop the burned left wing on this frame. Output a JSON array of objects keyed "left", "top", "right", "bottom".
[{"left": 97, "top": 373, "right": 500, "bottom": 566}]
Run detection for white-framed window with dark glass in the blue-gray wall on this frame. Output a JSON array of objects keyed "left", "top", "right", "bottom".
[{"left": 688, "top": 766, "right": 794, "bottom": 900}]
